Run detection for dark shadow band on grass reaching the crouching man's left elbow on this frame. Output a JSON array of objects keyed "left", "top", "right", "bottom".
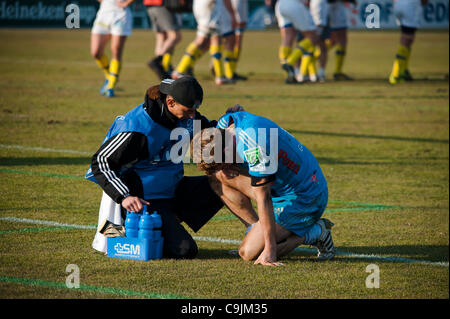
[{"left": 0, "top": 157, "right": 91, "bottom": 166}]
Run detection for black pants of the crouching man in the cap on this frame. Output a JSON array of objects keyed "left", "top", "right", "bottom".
[{"left": 139, "top": 176, "right": 223, "bottom": 259}]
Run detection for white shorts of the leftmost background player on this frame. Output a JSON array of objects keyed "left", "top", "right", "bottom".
[{"left": 91, "top": 8, "right": 133, "bottom": 36}]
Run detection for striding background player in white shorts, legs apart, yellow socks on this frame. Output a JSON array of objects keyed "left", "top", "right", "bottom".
[{"left": 172, "top": 0, "right": 234, "bottom": 85}]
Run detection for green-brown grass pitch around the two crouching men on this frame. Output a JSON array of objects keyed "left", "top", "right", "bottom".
[{"left": 0, "top": 29, "right": 449, "bottom": 299}]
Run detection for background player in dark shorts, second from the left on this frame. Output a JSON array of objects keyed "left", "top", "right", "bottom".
[{"left": 144, "top": 0, "right": 181, "bottom": 80}]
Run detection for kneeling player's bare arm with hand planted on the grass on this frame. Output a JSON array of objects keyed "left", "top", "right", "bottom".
[{"left": 252, "top": 176, "right": 281, "bottom": 266}]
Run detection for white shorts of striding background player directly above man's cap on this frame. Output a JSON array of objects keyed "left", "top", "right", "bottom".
[{"left": 192, "top": 0, "right": 233, "bottom": 37}]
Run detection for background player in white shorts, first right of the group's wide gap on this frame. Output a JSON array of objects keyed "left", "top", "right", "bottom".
[{"left": 277, "top": 0, "right": 319, "bottom": 83}]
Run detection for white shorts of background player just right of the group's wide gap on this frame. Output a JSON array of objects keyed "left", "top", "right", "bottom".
[{"left": 277, "top": 0, "right": 316, "bottom": 31}]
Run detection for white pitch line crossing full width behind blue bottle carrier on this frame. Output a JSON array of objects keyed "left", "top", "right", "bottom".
[{"left": 0, "top": 217, "right": 449, "bottom": 267}]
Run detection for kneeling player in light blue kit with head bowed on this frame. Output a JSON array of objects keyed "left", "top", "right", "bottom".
[{"left": 191, "top": 111, "right": 336, "bottom": 266}]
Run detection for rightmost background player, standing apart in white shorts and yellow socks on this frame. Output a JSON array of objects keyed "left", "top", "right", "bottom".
[{"left": 389, "top": 0, "right": 428, "bottom": 84}]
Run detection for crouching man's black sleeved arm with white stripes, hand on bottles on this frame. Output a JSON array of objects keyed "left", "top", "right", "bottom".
[{"left": 91, "top": 132, "right": 148, "bottom": 212}]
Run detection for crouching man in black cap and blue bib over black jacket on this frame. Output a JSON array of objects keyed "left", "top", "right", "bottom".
[{"left": 86, "top": 77, "right": 223, "bottom": 258}]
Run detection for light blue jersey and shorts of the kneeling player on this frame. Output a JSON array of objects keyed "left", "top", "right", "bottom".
[{"left": 217, "top": 111, "right": 328, "bottom": 237}]
